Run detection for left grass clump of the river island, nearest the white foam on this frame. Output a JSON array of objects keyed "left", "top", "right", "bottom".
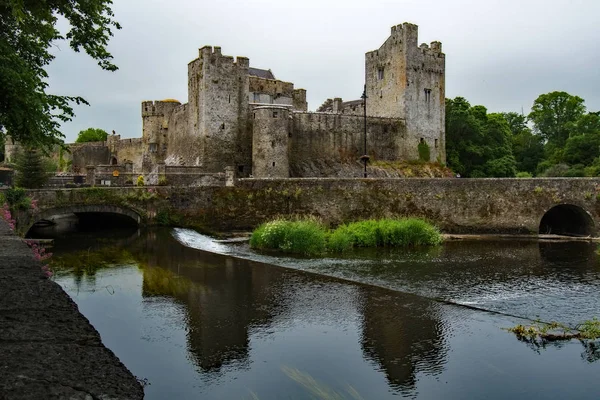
[{"left": 250, "top": 218, "right": 326, "bottom": 255}]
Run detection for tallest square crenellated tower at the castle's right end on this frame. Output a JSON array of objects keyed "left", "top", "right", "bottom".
[{"left": 365, "top": 23, "right": 446, "bottom": 162}]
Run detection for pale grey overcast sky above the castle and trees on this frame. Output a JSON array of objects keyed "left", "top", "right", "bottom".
[{"left": 49, "top": 0, "right": 600, "bottom": 142}]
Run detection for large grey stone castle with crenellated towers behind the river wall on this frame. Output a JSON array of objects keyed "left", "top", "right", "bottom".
[{"left": 7, "top": 23, "right": 446, "bottom": 178}]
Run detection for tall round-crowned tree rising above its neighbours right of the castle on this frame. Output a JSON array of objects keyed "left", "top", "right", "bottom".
[{"left": 528, "top": 92, "right": 585, "bottom": 147}]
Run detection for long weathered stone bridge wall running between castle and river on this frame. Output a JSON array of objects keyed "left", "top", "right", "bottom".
[{"left": 18, "top": 178, "right": 600, "bottom": 236}]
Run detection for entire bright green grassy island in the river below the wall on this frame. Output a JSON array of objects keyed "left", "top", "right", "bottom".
[{"left": 250, "top": 218, "right": 442, "bottom": 255}]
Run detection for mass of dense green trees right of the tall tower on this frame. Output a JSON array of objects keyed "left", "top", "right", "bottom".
[{"left": 446, "top": 92, "right": 600, "bottom": 178}]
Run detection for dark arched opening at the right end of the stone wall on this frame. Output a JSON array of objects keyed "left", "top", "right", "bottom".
[{"left": 539, "top": 204, "right": 597, "bottom": 236}]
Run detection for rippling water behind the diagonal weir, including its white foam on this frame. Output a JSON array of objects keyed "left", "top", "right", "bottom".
[{"left": 173, "top": 229, "right": 600, "bottom": 324}]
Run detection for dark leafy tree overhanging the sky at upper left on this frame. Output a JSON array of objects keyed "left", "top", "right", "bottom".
[{"left": 0, "top": 0, "right": 121, "bottom": 149}]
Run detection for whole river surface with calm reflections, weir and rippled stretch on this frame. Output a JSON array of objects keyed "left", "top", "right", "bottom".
[{"left": 46, "top": 229, "right": 600, "bottom": 399}]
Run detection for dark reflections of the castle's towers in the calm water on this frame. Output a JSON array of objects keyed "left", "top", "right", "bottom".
[{"left": 138, "top": 232, "right": 445, "bottom": 391}]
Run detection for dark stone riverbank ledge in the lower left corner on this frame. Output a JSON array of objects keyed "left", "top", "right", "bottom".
[{"left": 0, "top": 219, "right": 144, "bottom": 399}]
